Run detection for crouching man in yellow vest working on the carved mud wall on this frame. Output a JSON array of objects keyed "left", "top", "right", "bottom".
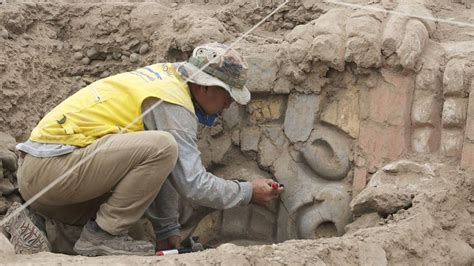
[{"left": 6, "top": 43, "right": 283, "bottom": 256}]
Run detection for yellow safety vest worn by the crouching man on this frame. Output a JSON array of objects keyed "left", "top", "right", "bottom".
[{"left": 30, "top": 64, "right": 194, "bottom": 147}]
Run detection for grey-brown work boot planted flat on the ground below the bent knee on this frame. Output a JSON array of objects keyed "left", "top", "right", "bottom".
[{"left": 74, "top": 221, "right": 155, "bottom": 256}]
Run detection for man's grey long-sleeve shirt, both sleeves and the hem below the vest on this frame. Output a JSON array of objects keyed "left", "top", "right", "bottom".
[{"left": 17, "top": 99, "right": 252, "bottom": 239}]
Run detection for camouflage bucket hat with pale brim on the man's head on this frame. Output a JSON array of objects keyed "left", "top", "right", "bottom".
[{"left": 178, "top": 43, "right": 250, "bottom": 105}]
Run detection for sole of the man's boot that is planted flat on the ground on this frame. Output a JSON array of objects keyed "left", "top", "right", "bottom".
[{"left": 74, "top": 240, "right": 155, "bottom": 257}]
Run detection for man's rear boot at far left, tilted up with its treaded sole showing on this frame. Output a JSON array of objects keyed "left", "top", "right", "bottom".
[{"left": 5, "top": 202, "right": 51, "bottom": 254}]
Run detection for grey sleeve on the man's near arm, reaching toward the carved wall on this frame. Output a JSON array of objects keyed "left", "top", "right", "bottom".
[{"left": 143, "top": 102, "right": 252, "bottom": 209}]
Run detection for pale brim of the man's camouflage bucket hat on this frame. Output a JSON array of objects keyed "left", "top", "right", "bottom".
[{"left": 178, "top": 62, "right": 251, "bottom": 105}]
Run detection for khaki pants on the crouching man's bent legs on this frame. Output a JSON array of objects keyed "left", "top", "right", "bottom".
[{"left": 18, "top": 131, "right": 178, "bottom": 234}]
